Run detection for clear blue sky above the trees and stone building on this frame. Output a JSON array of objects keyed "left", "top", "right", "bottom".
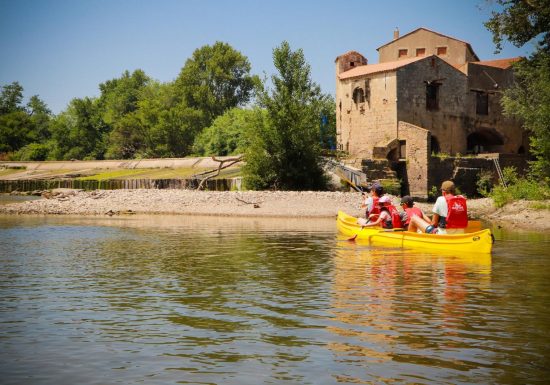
[{"left": 0, "top": 0, "right": 533, "bottom": 113}]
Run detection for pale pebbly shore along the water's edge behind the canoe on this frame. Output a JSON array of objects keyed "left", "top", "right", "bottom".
[{"left": 0, "top": 189, "right": 550, "bottom": 231}]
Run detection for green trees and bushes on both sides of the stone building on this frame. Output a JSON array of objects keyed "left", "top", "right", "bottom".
[{"left": 0, "top": 0, "right": 550, "bottom": 200}]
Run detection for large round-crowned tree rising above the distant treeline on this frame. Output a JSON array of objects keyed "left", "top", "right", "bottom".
[{"left": 175, "top": 41, "right": 259, "bottom": 128}]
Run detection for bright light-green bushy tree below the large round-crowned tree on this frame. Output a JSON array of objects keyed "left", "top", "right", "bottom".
[{"left": 194, "top": 108, "right": 261, "bottom": 156}]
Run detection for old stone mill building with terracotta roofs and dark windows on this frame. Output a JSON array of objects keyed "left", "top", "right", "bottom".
[{"left": 336, "top": 28, "right": 528, "bottom": 197}]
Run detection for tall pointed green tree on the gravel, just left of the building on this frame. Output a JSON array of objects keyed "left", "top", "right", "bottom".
[{"left": 243, "top": 41, "right": 326, "bottom": 190}]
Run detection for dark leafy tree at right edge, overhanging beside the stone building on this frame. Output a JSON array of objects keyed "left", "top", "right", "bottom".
[{"left": 485, "top": 0, "right": 550, "bottom": 183}]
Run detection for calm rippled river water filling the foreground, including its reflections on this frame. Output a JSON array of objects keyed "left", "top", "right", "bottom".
[{"left": 0, "top": 216, "right": 550, "bottom": 385}]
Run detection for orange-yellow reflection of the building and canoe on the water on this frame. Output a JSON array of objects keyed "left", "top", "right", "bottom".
[{"left": 329, "top": 244, "right": 490, "bottom": 382}]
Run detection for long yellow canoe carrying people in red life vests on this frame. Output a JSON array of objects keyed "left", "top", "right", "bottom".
[{"left": 336, "top": 211, "right": 493, "bottom": 253}]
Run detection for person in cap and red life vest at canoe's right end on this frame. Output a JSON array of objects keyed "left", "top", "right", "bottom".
[{"left": 409, "top": 180, "right": 468, "bottom": 234}]
